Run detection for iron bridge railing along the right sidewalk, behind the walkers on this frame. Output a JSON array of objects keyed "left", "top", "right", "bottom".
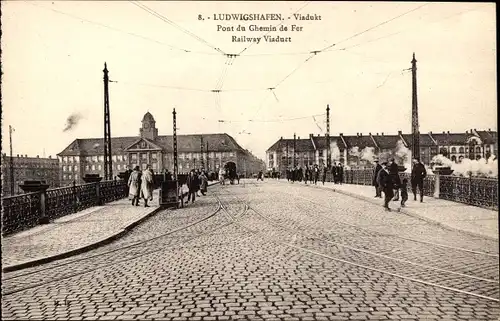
[{"left": 340, "top": 169, "right": 498, "bottom": 210}]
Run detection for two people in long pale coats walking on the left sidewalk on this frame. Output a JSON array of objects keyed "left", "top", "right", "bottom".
[{"left": 125, "top": 165, "right": 154, "bottom": 207}]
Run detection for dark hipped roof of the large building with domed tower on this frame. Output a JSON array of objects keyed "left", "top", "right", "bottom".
[{"left": 57, "top": 133, "right": 246, "bottom": 156}]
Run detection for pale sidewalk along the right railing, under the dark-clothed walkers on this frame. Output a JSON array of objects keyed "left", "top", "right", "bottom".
[{"left": 298, "top": 182, "right": 498, "bottom": 240}]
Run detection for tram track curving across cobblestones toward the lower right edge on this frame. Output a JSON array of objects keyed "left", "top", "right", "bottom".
[{"left": 212, "top": 190, "right": 499, "bottom": 302}]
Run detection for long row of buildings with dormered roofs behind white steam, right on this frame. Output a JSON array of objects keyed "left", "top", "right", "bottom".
[{"left": 266, "top": 129, "right": 498, "bottom": 171}]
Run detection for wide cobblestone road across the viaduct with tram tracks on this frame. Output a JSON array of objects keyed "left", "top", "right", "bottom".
[{"left": 2, "top": 181, "right": 500, "bottom": 320}]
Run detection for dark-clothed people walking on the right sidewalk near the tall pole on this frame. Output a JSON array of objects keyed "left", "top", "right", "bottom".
[{"left": 373, "top": 158, "right": 427, "bottom": 211}]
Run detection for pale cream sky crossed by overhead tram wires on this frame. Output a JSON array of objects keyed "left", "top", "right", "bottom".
[{"left": 1, "top": 1, "right": 497, "bottom": 159}]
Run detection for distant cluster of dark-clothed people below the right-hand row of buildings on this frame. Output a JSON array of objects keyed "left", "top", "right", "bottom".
[{"left": 286, "top": 163, "right": 344, "bottom": 185}]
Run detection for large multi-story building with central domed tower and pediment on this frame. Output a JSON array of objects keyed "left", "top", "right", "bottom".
[{"left": 57, "top": 112, "right": 265, "bottom": 185}]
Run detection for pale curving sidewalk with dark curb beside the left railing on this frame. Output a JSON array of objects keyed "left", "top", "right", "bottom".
[{"left": 2, "top": 181, "right": 219, "bottom": 272}]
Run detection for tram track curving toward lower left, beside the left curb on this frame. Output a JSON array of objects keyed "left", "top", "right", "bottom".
[{"left": 2, "top": 194, "right": 246, "bottom": 296}]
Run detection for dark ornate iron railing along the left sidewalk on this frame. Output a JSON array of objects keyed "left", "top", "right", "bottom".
[{"left": 2, "top": 180, "right": 128, "bottom": 235}]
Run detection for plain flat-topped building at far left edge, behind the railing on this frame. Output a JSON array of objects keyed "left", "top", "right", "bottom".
[{"left": 2, "top": 154, "right": 60, "bottom": 196}]
